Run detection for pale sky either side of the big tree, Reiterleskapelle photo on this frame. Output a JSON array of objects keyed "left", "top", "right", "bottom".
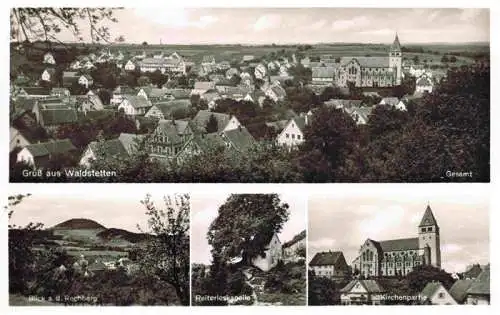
[{"left": 191, "top": 193, "right": 307, "bottom": 265}]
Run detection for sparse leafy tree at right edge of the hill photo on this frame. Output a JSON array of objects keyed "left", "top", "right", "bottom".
[{"left": 141, "top": 194, "right": 190, "bottom": 305}]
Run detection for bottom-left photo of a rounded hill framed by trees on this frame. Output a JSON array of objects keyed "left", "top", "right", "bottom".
[{"left": 5, "top": 187, "right": 190, "bottom": 306}]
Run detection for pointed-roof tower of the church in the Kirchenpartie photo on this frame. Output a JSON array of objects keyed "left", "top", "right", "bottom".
[{"left": 418, "top": 205, "right": 441, "bottom": 268}]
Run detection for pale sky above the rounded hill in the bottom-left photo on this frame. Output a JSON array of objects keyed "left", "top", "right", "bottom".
[{"left": 10, "top": 185, "right": 188, "bottom": 232}]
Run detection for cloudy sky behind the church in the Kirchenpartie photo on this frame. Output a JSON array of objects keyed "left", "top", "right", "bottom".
[{"left": 308, "top": 192, "right": 490, "bottom": 272}]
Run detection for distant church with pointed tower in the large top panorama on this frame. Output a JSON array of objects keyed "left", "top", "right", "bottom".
[{"left": 334, "top": 34, "right": 403, "bottom": 87}]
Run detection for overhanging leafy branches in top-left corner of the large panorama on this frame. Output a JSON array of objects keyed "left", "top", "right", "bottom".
[{"left": 10, "top": 8, "right": 118, "bottom": 43}]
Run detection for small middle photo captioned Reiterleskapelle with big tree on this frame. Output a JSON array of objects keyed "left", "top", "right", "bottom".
[{"left": 191, "top": 194, "right": 307, "bottom": 306}]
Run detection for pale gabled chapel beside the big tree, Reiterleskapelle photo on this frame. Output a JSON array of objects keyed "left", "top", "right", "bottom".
[{"left": 252, "top": 232, "right": 283, "bottom": 272}]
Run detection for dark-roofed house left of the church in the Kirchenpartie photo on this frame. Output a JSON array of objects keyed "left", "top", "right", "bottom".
[{"left": 309, "top": 251, "right": 350, "bottom": 278}]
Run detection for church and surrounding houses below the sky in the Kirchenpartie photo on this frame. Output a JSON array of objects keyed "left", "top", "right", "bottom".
[{"left": 308, "top": 205, "right": 490, "bottom": 305}]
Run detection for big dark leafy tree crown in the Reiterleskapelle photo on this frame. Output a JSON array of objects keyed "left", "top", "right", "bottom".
[{"left": 207, "top": 194, "right": 289, "bottom": 264}]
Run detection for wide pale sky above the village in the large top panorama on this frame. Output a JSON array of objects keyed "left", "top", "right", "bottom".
[{"left": 21, "top": 7, "right": 490, "bottom": 45}]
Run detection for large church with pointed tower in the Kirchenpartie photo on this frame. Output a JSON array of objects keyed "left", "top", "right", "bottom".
[{"left": 352, "top": 205, "right": 441, "bottom": 277}]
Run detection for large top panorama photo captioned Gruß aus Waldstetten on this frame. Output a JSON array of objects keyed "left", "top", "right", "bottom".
[{"left": 9, "top": 7, "right": 490, "bottom": 183}]
